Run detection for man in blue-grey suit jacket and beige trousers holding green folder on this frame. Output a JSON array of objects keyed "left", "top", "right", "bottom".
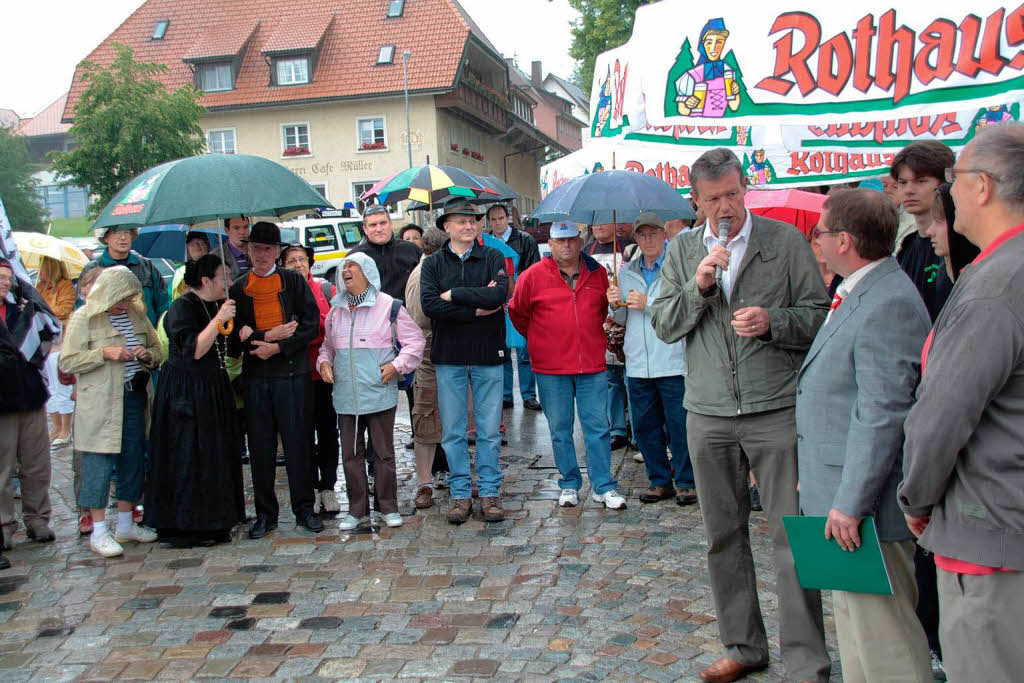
[{"left": 797, "top": 189, "right": 934, "bottom": 683}]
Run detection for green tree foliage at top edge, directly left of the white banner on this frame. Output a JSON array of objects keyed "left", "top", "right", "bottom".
[{"left": 569, "top": 0, "right": 650, "bottom": 95}]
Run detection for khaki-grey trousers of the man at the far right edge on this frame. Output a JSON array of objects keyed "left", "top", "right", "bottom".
[{"left": 938, "top": 569, "right": 1024, "bottom": 683}]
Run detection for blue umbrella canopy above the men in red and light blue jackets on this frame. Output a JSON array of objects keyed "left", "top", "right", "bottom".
[{"left": 530, "top": 171, "right": 695, "bottom": 225}]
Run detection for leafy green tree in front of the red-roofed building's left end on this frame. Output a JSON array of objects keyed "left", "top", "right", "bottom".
[{"left": 52, "top": 43, "right": 205, "bottom": 215}]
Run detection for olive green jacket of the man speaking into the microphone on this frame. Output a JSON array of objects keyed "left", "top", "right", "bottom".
[{"left": 651, "top": 216, "right": 828, "bottom": 417}]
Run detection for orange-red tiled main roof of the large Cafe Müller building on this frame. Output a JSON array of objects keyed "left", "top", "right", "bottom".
[{"left": 63, "top": 0, "right": 486, "bottom": 120}]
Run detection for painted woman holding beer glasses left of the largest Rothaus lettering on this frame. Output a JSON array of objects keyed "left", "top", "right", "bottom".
[{"left": 666, "top": 18, "right": 740, "bottom": 119}]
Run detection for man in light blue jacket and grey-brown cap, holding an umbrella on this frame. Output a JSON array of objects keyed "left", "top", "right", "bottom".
[{"left": 608, "top": 212, "right": 697, "bottom": 505}]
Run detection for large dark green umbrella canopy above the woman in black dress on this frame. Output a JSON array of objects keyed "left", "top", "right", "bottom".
[{"left": 92, "top": 155, "right": 334, "bottom": 229}]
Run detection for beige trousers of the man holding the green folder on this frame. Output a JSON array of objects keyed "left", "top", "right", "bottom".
[{"left": 833, "top": 541, "right": 935, "bottom": 683}]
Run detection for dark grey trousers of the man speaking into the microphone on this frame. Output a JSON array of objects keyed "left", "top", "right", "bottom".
[{"left": 686, "top": 408, "right": 831, "bottom": 683}]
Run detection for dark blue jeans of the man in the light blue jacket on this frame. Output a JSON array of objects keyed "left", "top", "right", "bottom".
[{"left": 626, "top": 375, "right": 695, "bottom": 488}]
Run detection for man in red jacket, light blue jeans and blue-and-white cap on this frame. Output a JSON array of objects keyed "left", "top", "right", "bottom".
[{"left": 509, "top": 222, "right": 626, "bottom": 510}]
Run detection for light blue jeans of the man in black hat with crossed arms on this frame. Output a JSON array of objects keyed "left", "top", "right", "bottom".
[{"left": 434, "top": 365, "right": 502, "bottom": 500}]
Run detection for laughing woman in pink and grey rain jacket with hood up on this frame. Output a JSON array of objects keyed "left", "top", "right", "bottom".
[{"left": 316, "top": 253, "right": 425, "bottom": 530}]
